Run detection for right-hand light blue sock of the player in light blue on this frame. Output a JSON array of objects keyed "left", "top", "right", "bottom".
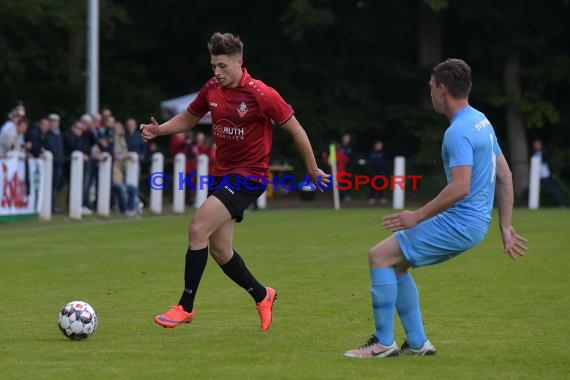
[{"left": 394, "top": 272, "right": 426, "bottom": 349}]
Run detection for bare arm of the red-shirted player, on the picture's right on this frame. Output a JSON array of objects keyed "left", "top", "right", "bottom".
[{"left": 281, "top": 115, "right": 330, "bottom": 191}]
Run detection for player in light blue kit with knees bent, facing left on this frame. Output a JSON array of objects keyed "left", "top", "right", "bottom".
[{"left": 345, "top": 59, "right": 527, "bottom": 357}]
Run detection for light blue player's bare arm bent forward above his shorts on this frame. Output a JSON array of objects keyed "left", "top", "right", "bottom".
[{"left": 382, "top": 165, "right": 472, "bottom": 231}]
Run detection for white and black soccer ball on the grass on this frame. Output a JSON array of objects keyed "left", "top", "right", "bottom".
[{"left": 57, "top": 301, "right": 97, "bottom": 340}]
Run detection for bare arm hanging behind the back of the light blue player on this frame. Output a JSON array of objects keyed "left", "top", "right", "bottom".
[{"left": 495, "top": 154, "right": 527, "bottom": 260}]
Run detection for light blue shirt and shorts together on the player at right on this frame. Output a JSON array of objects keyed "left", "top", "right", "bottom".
[{"left": 396, "top": 106, "right": 502, "bottom": 267}]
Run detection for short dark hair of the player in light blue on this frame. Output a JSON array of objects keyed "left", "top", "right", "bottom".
[{"left": 431, "top": 58, "right": 471, "bottom": 99}]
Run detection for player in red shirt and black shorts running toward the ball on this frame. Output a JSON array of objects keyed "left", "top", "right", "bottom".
[{"left": 140, "top": 33, "right": 330, "bottom": 331}]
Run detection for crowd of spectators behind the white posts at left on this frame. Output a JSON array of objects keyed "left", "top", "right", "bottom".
[{"left": 0, "top": 102, "right": 216, "bottom": 217}]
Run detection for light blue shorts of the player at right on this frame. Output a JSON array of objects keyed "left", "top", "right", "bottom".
[{"left": 396, "top": 213, "right": 488, "bottom": 268}]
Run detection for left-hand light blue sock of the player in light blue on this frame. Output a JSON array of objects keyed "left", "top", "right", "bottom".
[{"left": 370, "top": 268, "right": 394, "bottom": 346}]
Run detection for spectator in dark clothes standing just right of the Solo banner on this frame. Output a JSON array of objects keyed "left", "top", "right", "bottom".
[{"left": 45, "top": 113, "right": 65, "bottom": 214}]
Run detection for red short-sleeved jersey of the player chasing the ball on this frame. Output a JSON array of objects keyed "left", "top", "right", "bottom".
[{"left": 188, "top": 69, "right": 293, "bottom": 178}]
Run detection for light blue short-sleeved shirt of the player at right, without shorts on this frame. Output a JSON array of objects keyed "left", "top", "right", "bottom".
[{"left": 441, "top": 106, "right": 502, "bottom": 232}]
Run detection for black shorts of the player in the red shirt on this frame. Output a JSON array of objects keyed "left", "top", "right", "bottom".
[{"left": 208, "top": 174, "right": 267, "bottom": 223}]
